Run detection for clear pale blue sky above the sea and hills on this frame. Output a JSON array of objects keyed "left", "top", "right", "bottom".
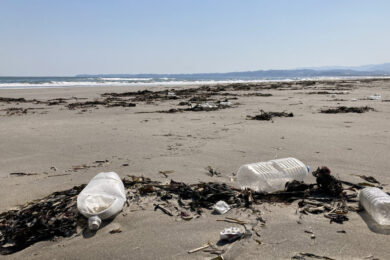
[{"left": 0, "top": 0, "right": 390, "bottom": 76}]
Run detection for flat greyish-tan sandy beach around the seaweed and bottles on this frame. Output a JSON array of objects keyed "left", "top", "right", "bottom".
[{"left": 0, "top": 79, "right": 390, "bottom": 259}]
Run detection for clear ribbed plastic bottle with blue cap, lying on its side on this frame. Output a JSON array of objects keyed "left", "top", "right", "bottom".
[{"left": 237, "top": 158, "right": 310, "bottom": 192}]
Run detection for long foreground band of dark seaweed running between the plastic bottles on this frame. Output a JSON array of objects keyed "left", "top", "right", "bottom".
[{"left": 0, "top": 167, "right": 376, "bottom": 255}]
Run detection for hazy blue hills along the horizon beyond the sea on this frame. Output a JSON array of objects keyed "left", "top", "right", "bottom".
[{"left": 76, "top": 63, "right": 390, "bottom": 80}]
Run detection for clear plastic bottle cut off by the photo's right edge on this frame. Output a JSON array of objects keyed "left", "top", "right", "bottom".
[{"left": 359, "top": 187, "right": 390, "bottom": 225}]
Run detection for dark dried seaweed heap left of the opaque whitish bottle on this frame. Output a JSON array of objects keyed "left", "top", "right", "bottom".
[{"left": 0, "top": 185, "right": 85, "bottom": 255}]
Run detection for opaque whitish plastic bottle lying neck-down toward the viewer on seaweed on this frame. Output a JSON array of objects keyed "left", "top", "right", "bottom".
[{"left": 77, "top": 172, "right": 126, "bottom": 230}]
